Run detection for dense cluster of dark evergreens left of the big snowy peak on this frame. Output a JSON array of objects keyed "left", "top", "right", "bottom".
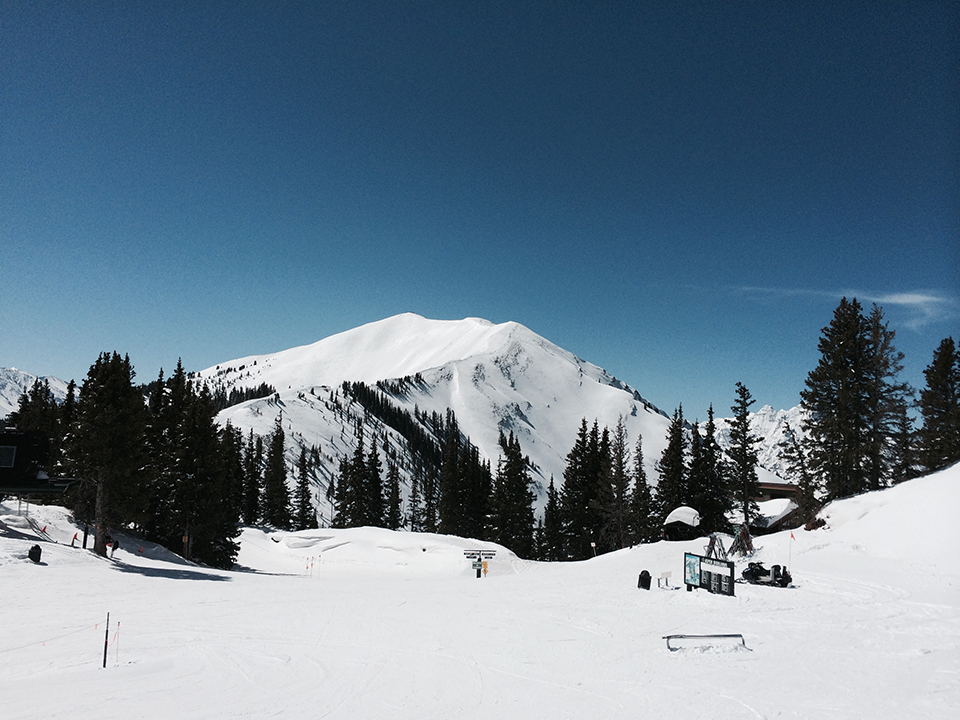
[{"left": 7, "top": 352, "right": 319, "bottom": 568}]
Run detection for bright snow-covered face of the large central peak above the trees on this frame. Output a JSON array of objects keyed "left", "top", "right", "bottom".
[{"left": 210, "top": 314, "right": 668, "bottom": 504}]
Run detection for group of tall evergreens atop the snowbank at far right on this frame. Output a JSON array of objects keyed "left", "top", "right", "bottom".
[{"left": 782, "top": 298, "right": 960, "bottom": 505}]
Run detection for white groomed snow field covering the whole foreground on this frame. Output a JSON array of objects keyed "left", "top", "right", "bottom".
[{"left": 0, "top": 466, "right": 960, "bottom": 720}]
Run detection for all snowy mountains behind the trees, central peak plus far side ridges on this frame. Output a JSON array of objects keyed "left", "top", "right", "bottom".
[{"left": 0, "top": 313, "right": 799, "bottom": 511}]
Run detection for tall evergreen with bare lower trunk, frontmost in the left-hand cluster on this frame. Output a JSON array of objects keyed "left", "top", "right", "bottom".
[{"left": 72, "top": 352, "right": 149, "bottom": 556}]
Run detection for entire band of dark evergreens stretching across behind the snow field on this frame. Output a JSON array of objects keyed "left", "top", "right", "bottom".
[{"left": 9, "top": 298, "right": 960, "bottom": 567}]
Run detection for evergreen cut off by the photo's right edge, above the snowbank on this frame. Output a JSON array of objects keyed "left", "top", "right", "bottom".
[{"left": 918, "top": 337, "right": 960, "bottom": 472}]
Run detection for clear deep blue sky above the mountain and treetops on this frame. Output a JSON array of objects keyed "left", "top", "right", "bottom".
[{"left": 0, "top": 0, "right": 960, "bottom": 419}]
